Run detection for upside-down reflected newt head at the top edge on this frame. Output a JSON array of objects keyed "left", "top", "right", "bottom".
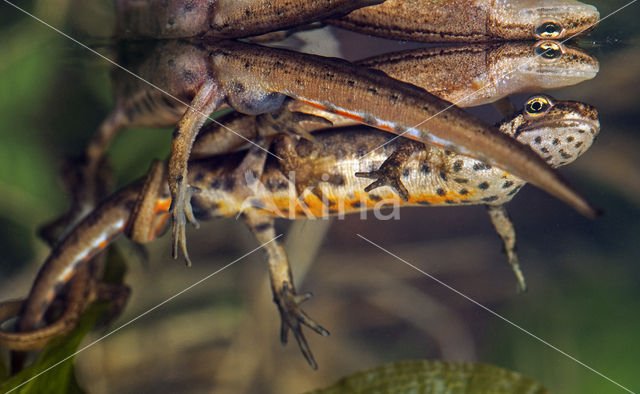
[{"left": 490, "top": 0, "right": 600, "bottom": 40}]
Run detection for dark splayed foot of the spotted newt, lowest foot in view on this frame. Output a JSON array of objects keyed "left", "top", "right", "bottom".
[{"left": 274, "top": 282, "right": 329, "bottom": 369}]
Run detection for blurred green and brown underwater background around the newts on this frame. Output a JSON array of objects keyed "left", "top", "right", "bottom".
[{"left": 0, "top": 0, "right": 640, "bottom": 393}]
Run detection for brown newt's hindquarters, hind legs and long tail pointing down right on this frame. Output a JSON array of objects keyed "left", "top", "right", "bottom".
[{"left": 72, "top": 41, "right": 598, "bottom": 264}]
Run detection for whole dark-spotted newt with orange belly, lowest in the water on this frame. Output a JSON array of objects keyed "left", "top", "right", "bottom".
[{"left": 5, "top": 96, "right": 599, "bottom": 368}]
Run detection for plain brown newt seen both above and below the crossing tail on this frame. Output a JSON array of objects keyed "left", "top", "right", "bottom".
[{"left": 191, "top": 41, "right": 599, "bottom": 157}]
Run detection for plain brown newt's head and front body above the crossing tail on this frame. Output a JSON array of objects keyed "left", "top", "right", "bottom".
[{"left": 358, "top": 41, "right": 599, "bottom": 107}]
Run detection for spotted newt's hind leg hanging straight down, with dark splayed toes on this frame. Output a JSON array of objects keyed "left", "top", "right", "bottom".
[{"left": 243, "top": 209, "right": 329, "bottom": 369}]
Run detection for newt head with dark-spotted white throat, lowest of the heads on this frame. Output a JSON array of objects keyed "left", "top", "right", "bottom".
[{"left": 500, "top": 95, "right": 600, "bottom": 167}]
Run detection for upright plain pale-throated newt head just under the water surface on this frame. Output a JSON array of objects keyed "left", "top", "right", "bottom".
[{"left": 495, "top": 40, "right": 600, "bottom": 92}]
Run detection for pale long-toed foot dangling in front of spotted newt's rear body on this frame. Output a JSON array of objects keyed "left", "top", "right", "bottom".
[{"left": 170, "top": 183, "right": 200, "bottom": 267}]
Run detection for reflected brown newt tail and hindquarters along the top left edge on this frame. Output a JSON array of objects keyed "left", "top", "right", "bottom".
[{"left": 115, "top": 0, "right": 384, "bottom": 39}]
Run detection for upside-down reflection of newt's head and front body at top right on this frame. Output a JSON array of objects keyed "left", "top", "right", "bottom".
[{"left": 329, "top": 0, "right": 600, "bottom": 42}]
